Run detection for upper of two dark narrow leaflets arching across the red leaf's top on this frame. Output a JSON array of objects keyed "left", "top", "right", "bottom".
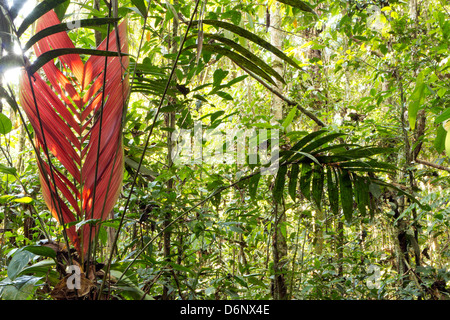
[{"left": 24, "top": 18, "right": 120, "bottom": 51}]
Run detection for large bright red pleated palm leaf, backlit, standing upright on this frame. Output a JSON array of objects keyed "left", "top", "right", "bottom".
[{"left": 20, "top": 11, "right": 129, "bottom": 254}]
